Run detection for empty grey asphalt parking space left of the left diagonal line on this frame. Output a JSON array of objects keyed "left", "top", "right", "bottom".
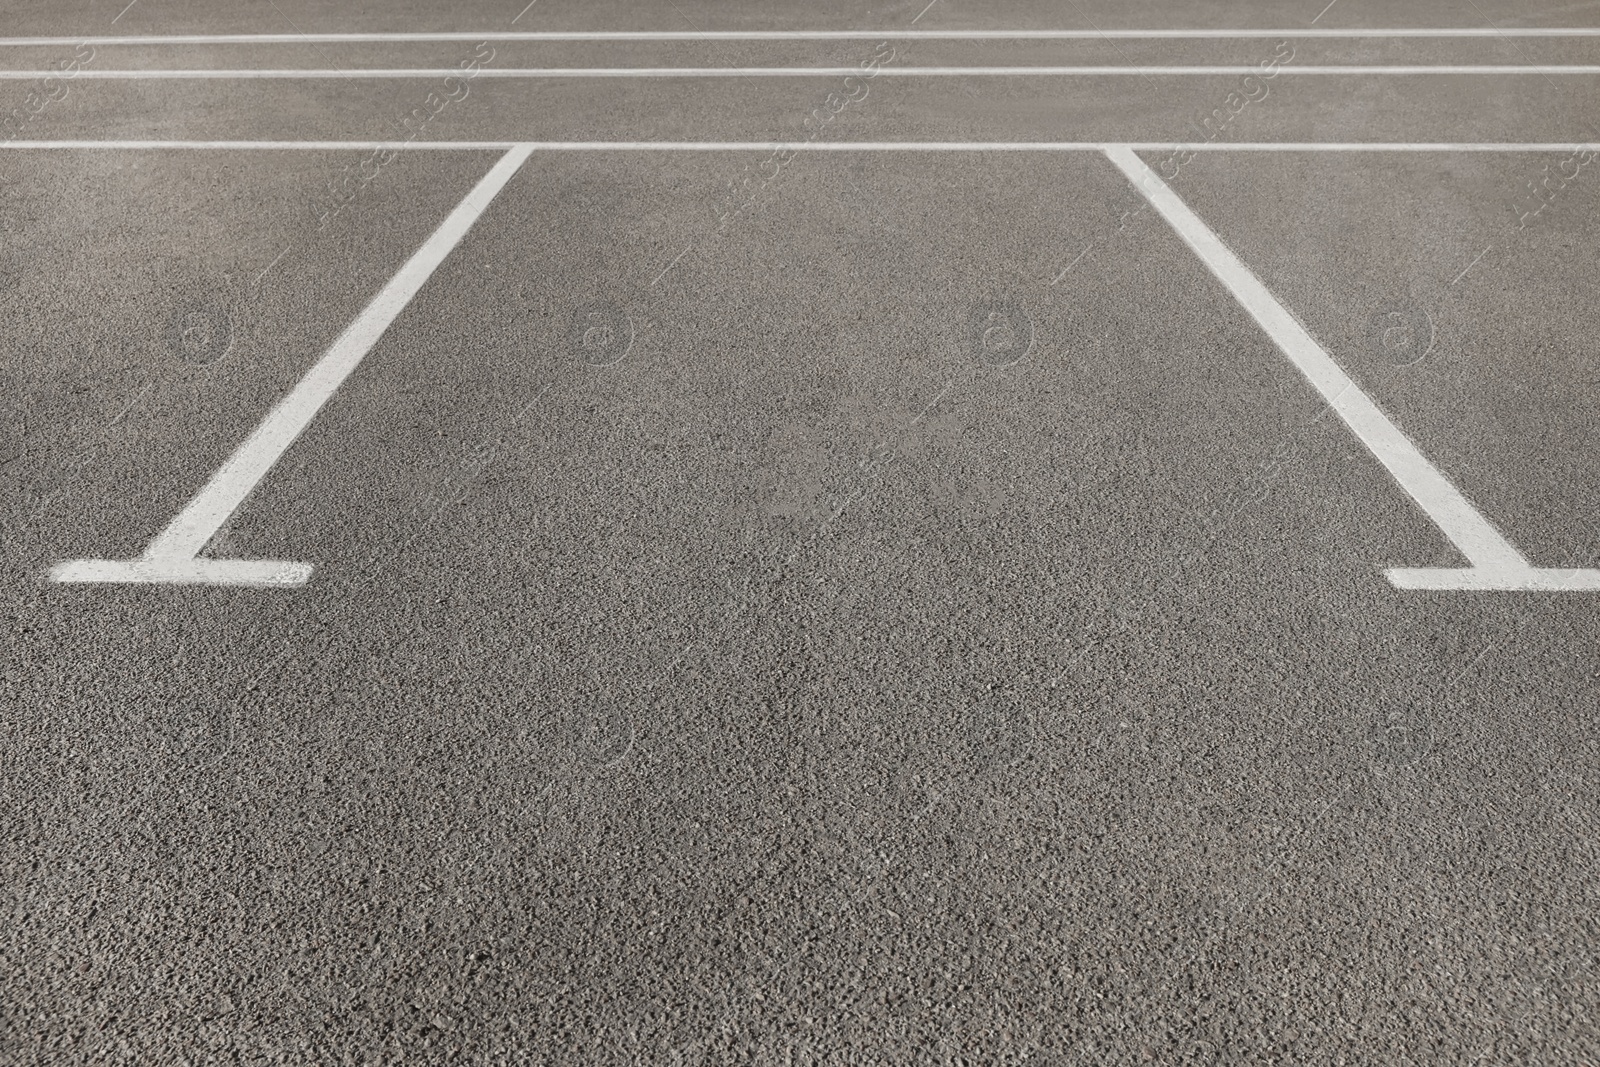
[{"left": 5, "top": 152, "right": 499, "bottom": 579}]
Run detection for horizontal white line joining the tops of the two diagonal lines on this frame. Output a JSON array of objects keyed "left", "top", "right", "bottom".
[{"left": 0, "top": 141, "right": 1600, "bottom": 154}]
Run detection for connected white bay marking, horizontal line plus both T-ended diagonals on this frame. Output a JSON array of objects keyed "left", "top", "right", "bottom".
[{"left": 31, "top": 141, "right": 1600, "bottom": 592}]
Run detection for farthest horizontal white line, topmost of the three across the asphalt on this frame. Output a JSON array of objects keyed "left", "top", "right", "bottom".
[{"left": 0, "top": 26, "right": 1600, "bottom": 48}]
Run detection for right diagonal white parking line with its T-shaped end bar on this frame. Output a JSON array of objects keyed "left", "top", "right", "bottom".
[{"left": 1106, "top": 147, "right": 1600, "bottom": 590}]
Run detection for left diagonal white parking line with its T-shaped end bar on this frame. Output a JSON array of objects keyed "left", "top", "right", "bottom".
[{"left": 50, "top": 147, "right": 533, "bottom": 585}]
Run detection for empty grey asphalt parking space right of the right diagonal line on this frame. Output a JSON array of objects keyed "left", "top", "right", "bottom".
[{"left": 1181, "top": 152, "right": 1600, "bottom": 566}]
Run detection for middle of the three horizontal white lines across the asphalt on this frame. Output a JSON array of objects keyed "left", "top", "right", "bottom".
[{"left": 0, "top": 64, "right": 1600, "bottom": 82}]
